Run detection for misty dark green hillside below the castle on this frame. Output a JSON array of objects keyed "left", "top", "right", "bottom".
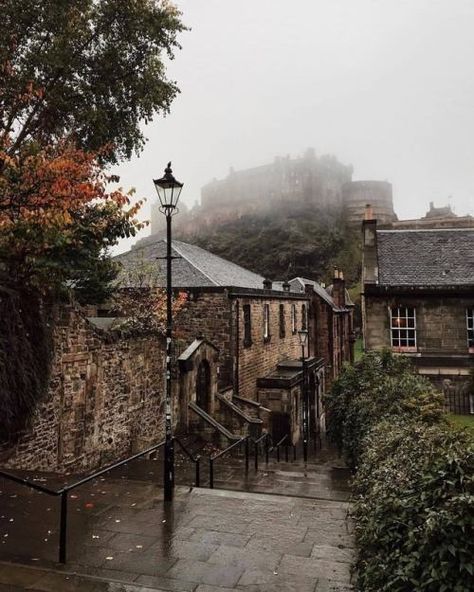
[{"left": 178, "top": 204, "right": 361, "bottom": 286}]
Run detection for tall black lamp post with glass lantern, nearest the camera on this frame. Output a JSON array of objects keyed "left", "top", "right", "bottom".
[{"left": 153, "top": 162, "right": 183, "bottom": 502}]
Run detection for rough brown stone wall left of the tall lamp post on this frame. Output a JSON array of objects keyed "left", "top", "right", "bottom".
[{"left": 2, "top": 309, "right": 167, "bottom": 472}]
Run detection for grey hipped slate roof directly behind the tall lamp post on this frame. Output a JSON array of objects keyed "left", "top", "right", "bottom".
[{"left": 114, "top": 240, "right": 264, "bottom": 289}]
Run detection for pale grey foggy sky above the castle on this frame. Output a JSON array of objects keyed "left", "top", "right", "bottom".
[{"left": 117, "top": 0, "right": 474, "bottom": 251}]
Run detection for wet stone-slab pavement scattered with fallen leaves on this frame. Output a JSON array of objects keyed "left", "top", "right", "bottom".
[{"left": 0, "top": 448, "right": 353, "bottom": 592}]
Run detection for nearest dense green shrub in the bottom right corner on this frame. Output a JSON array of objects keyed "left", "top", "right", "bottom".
[{"left": 353, "top": 421, "right": 474, "bottom": 592}]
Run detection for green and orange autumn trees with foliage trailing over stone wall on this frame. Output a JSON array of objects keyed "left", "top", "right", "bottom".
[{"left": 0, "top": 0, "right": 184, "bottom": 441}]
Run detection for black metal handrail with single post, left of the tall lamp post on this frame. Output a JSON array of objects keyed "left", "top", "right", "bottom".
[{"left": 0, "top": 442, "right": 165, "bottom": 563}]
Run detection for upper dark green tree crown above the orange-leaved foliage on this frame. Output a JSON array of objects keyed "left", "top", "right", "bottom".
[{"left": 0, "top": 0, "right": 185, "bottom": 162}]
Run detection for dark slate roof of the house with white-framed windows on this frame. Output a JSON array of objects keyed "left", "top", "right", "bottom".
[{"left": 377, "top": 228, "right": 474, "bottom": 286}]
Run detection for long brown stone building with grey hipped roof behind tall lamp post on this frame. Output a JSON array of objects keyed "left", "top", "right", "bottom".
[{"left": 118, "top": 241, "right": 352, "bottom": 441}]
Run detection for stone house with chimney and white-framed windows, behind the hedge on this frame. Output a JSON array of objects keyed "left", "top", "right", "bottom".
[{"left": 362, "top": 219, "right": 474, "bottom": 412}]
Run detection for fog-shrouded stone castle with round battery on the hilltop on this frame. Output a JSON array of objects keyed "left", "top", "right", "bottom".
[{"left": 151, "top": 148, "right": 397, "bottom": 234}]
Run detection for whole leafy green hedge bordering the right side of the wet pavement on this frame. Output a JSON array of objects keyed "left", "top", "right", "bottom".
[{"left": 327, "top": 352, "right": 474, "bottom": 592}]
